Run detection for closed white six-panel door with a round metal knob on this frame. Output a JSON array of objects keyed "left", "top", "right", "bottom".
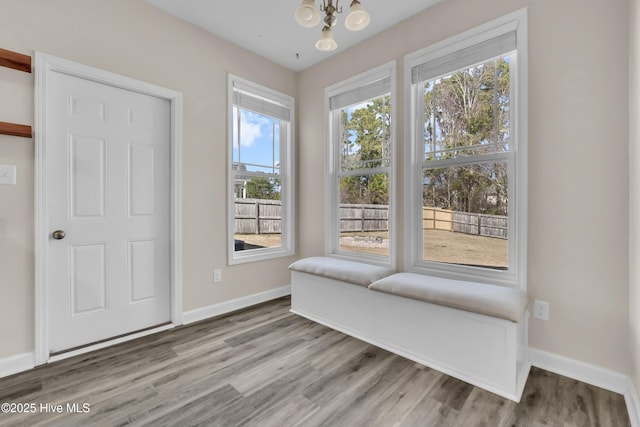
[{"left": 45, "top": 72, "right": 171, "bottom": 353}]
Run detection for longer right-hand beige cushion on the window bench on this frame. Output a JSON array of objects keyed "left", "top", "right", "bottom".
[{"left": 369, "top": 273, "right": 528, "bottom": 322}]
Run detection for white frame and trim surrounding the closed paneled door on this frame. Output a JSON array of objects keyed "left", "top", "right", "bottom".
[{"left": 34, "top": 51, "right": 182, "bottom": 366}]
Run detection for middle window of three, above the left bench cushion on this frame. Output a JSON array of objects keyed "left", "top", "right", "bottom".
[{"left": 325, "top": 64, "right": 395, "bottom": 265}]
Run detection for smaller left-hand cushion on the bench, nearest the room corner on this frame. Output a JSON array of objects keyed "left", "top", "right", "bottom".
[{"left": 289, "top": 257, "right": 395, "bottom": 287}]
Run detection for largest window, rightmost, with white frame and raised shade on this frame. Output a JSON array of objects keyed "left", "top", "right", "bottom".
[{"left": 405, "top": 12, "right": 526, "bottom": 286}]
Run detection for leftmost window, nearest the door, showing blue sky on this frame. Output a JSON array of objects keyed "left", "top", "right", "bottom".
[{"left": 228, "top": 75, "right": 294, "bottom": 264}]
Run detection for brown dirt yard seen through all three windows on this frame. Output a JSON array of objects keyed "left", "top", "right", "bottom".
[{"left": 235, "top": 230, "right": 509, "bottom": 269}]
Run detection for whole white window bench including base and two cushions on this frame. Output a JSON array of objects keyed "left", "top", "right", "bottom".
[{"left": 290, "top": 257, "right": 531, "bottom": 402}]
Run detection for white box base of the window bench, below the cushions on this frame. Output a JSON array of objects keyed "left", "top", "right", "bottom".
[{"left": 291, "top": 271, "right": 531, "bottom": 402}]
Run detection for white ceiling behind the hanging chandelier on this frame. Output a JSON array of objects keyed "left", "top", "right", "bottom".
[{"left": 145, "top": 0, "right": 441, "bottom": 71}]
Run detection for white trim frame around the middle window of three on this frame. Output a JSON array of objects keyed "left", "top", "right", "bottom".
[{"left": 324, "top": 61, "right": 398, "bottom": 268}]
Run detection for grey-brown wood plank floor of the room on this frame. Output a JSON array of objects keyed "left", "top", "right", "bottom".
[{"left": 0, "top": 298, "right": 630, "bottom": 427}]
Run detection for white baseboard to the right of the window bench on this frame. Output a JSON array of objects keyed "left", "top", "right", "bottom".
[{"left": 529, "top": 348, "right": 640, "bottom": 427}]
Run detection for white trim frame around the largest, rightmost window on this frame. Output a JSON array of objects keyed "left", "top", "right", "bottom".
[{"left": 404, "top": 8, "right": 528, "bottom": 290}]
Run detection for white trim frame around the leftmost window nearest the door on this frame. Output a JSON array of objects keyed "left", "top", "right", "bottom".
[{"left": 227, "top": 74, "right": 295, "bottom": 265}]
